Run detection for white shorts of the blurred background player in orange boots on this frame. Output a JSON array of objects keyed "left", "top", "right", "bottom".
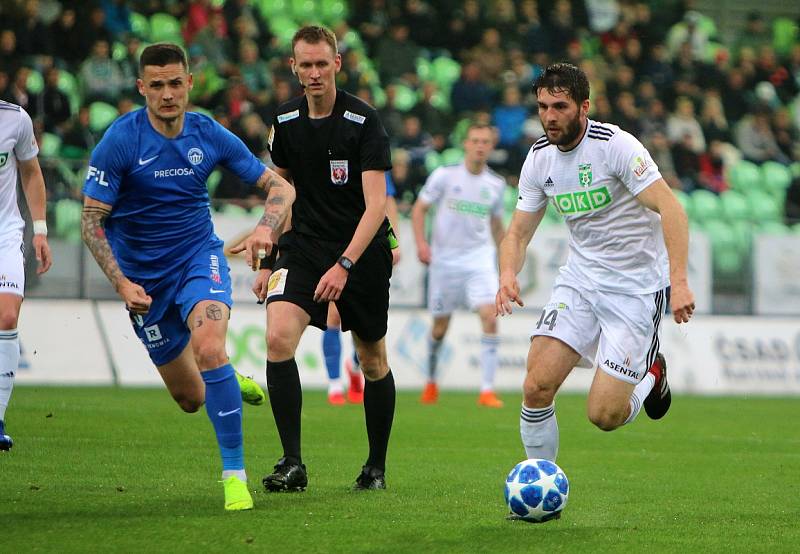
[{"left": 428, "top": 265, "right": 498, "bottom": 316}]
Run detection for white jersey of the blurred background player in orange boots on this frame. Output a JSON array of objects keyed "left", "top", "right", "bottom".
[{"left": 419, "top": 163, "right": 506, "bottom": 268}]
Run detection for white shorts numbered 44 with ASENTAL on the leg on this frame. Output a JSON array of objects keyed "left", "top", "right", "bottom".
[{"left": 531, "top": 285, "right": 666, "bottom": 384}]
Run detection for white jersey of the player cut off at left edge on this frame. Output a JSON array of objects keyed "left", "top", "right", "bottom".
[{"left": 0, "top": 101, "right": 39, "bottom": 239}]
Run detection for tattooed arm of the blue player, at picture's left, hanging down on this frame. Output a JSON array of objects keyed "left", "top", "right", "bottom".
[{"left": 81, "top": 196, "right": 152, "bottom": 314}]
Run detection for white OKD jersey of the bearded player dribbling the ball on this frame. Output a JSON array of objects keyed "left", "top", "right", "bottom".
[{"left": 517, "top": 120, "right": 669, "bottom": 294}]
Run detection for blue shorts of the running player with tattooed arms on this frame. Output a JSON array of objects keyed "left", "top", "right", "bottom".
[{"left": 130, "top": 247, "right": 233, "bottom": 366}]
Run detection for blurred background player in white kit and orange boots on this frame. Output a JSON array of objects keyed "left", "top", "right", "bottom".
[{"left": 411, "top": 124, "right": 506, "bottom": 408}]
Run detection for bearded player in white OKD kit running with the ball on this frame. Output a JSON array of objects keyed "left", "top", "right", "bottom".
[{"left": 496, "top": 63, "right": 694, "bottom": 460}]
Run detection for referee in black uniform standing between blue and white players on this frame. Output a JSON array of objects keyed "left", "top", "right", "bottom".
[{"left": 255, "top": 26, "right": 395, "bottom": 491}]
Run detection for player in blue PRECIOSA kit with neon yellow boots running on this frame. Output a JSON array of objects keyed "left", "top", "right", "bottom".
[{"left": 81, "top": 44, "right": 294, "bottom": 510}]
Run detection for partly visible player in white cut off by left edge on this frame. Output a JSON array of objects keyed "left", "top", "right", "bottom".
[{"left": 0, "top": 101, "right": 51, "bottom": 450}]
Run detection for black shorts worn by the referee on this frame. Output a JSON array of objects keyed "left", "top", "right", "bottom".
[{"left": 267, "top": 231, "right": 392, "bottom": 342}]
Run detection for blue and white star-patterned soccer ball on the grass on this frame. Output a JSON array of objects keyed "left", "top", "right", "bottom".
[{"left": 505, "top": 458, "right": 569, "bottom": 522}]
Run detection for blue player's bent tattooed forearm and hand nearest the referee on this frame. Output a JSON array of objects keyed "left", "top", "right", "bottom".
[{"left": 231, "top": 168, "right": 295, "bottom": 271}]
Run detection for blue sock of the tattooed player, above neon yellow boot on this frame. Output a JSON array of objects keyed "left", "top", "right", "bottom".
[{"left": 200, "top": 364, "right": 244, "bottom": 471}]
